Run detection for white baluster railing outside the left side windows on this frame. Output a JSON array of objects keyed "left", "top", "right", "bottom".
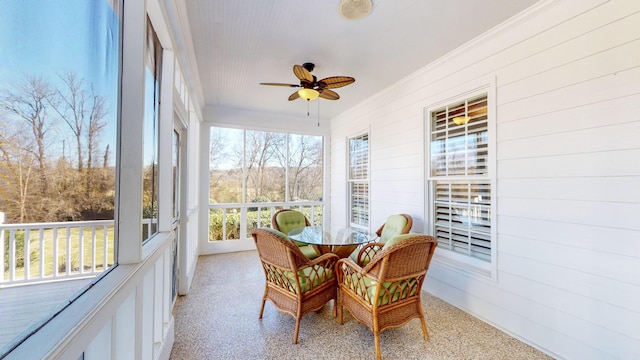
[{"left": 0, "top": 219, "right": 156, "bottom": 287}]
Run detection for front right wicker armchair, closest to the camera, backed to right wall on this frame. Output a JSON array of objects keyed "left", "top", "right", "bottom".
[{"left": 336, "top": 234, "right": 437, "bottom": 359}]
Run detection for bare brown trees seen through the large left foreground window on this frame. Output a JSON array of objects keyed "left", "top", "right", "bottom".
[{"left": 0, "top": 73, "right": 115, "bottom": 223}]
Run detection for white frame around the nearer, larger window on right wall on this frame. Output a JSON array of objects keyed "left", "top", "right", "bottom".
[{"left": 423, "top": 83, "right": 498, "bottom": 281}]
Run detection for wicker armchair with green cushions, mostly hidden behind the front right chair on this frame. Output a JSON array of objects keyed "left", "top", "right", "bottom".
[{"left": 351, "top": 214, "right": 413, "bottom": 266}]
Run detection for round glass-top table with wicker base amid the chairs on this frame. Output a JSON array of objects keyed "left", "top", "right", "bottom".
[{"left": 287, "top": 226, "right": 376, "bottom": 258}]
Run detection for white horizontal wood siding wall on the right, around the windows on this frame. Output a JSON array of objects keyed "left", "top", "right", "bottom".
[{"left": 332, "top": 0, "right": 640, "bottom": 359}]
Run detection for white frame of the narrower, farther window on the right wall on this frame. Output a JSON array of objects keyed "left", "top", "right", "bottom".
[{"left": 346, "top": 130, "right": 371, "bottom": 232}]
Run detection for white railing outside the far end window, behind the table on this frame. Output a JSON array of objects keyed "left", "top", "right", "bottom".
[{"left": 209, "top": 201, "right": 324, "bottom": 241}]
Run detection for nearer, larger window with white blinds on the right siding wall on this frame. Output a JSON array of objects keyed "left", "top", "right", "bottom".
[{"left": 429, "top": 94, "right": 492, "bottom": 262}]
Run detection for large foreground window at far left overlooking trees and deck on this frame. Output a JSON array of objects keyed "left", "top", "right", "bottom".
[{"left": 0, "top": 0, "right": 121, "bottom": 358}]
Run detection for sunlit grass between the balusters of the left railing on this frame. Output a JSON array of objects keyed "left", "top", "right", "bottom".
[{"left": 4, "top": 225, "right": 114, "bottom": 280}]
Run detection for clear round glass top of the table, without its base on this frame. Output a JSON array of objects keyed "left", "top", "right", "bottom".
[{"left": 287, "top": 226, "right": 376, "bottom": 246}]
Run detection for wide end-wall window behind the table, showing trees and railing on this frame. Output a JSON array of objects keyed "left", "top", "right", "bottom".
[{"left": 209, "top": 127, "right": 323, "bottom": 241}]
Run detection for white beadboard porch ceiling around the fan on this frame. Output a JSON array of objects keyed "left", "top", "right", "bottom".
[{"left": 180, "top": 0, "right": 536, "bottom": 119}]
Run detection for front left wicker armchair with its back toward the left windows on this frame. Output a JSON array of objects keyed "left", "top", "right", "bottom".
[{"left": 251, "top": 229, "right": 339, "bottom": 344}]
